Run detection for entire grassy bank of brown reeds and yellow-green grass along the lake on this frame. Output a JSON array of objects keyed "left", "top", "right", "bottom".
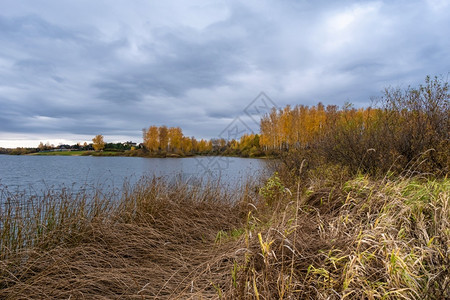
[{"left": 0, "top": 171, "right": 450, "bottom": 299}]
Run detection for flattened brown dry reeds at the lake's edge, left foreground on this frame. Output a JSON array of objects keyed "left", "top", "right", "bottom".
[{"left": 0, "top": 179, "right": 253, "bottom": 299}]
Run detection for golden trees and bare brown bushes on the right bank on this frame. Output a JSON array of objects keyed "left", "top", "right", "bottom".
[{"left": 268, "top": 77, "right": 450, "bottom": 175}]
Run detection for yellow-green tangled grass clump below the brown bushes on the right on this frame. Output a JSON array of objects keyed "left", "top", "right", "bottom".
[{"left": 226, "top": 176, "right": 450, "bottom": 299}]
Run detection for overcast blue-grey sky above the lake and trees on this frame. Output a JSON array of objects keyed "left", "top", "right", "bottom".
[{"left": 0, "top": 0, "right": 450, "bottom": 147}]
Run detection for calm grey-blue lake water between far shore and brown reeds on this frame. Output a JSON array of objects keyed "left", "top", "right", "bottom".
[{"left": 0, "top": 155, "right": 267, "bottom": 194}]
